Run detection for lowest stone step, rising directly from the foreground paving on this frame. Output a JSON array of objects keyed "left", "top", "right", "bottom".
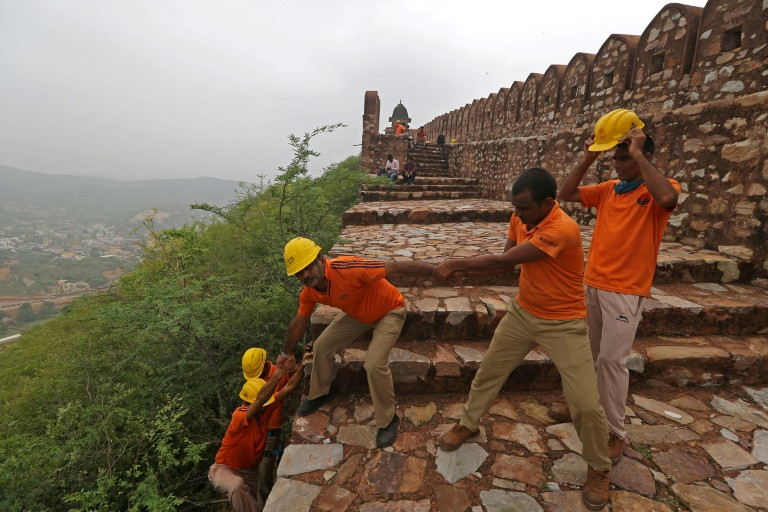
[{"left": 307, "top": 335, "right": 768, "bottom": 394}]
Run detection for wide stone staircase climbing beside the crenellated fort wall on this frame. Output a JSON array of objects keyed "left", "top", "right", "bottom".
[{"left": 265, "top": 187, "right": 768, "bottom": 512}]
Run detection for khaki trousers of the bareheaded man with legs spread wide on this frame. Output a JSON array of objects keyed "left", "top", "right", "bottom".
[{"left": 460, "top": 300, "right": 611, "bottom": 471}]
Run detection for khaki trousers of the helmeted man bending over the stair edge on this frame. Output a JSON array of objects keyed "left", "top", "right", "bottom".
[{"left": 308, "top": 308, "right": 405, "bottom": 428}]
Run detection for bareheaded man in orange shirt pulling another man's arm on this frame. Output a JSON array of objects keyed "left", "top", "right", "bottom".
[{"left": 435, "top": 168, "right": 611, "bottom": 510}]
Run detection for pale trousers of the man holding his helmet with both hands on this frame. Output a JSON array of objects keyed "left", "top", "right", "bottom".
[{"left": 586, "top": 286, "right": 645, "bottom": 439}]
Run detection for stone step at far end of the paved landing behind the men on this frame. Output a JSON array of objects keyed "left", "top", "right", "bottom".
[{"left": 343, "top": 199, "right": 514, "bottom": 226}]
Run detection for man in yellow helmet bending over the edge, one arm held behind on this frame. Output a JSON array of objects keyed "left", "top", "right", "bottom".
[{"left": 277, "top": 237, "right": 434, "bottom": 448}]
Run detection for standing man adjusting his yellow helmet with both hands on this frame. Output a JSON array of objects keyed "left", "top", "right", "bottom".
[{"left": 550, "top": 109, "right": 680, "bottom": 464}]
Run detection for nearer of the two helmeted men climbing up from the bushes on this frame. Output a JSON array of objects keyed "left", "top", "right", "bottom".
[{"left": 208, "top": 354, "right": 310, "bottom": 512}]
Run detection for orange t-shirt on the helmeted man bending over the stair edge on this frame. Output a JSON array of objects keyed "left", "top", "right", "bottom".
[{"left": 299, "top": 256, "right": 405, "bottom": 324}]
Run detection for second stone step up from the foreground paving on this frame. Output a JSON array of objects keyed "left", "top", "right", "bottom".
[{"left": 312, "top": 281, "right": 768, "bottom": 341}]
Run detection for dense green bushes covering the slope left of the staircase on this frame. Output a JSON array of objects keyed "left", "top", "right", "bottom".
[{"left": 0, "top": 125, "right": 367, "bottom": 511}]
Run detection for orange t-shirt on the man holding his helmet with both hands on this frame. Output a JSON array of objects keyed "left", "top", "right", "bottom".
[{"left": 579, "top": 179, "right": 680, "bottom": 297}]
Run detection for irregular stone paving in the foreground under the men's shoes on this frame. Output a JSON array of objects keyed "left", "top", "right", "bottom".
[{"left": 265, "top": 382, "right": 768, "bottom": 512}]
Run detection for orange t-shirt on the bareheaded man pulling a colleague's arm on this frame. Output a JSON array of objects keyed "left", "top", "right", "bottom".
[{"left": 508, "top": 203, "right": 587, "bottom": 320}]
